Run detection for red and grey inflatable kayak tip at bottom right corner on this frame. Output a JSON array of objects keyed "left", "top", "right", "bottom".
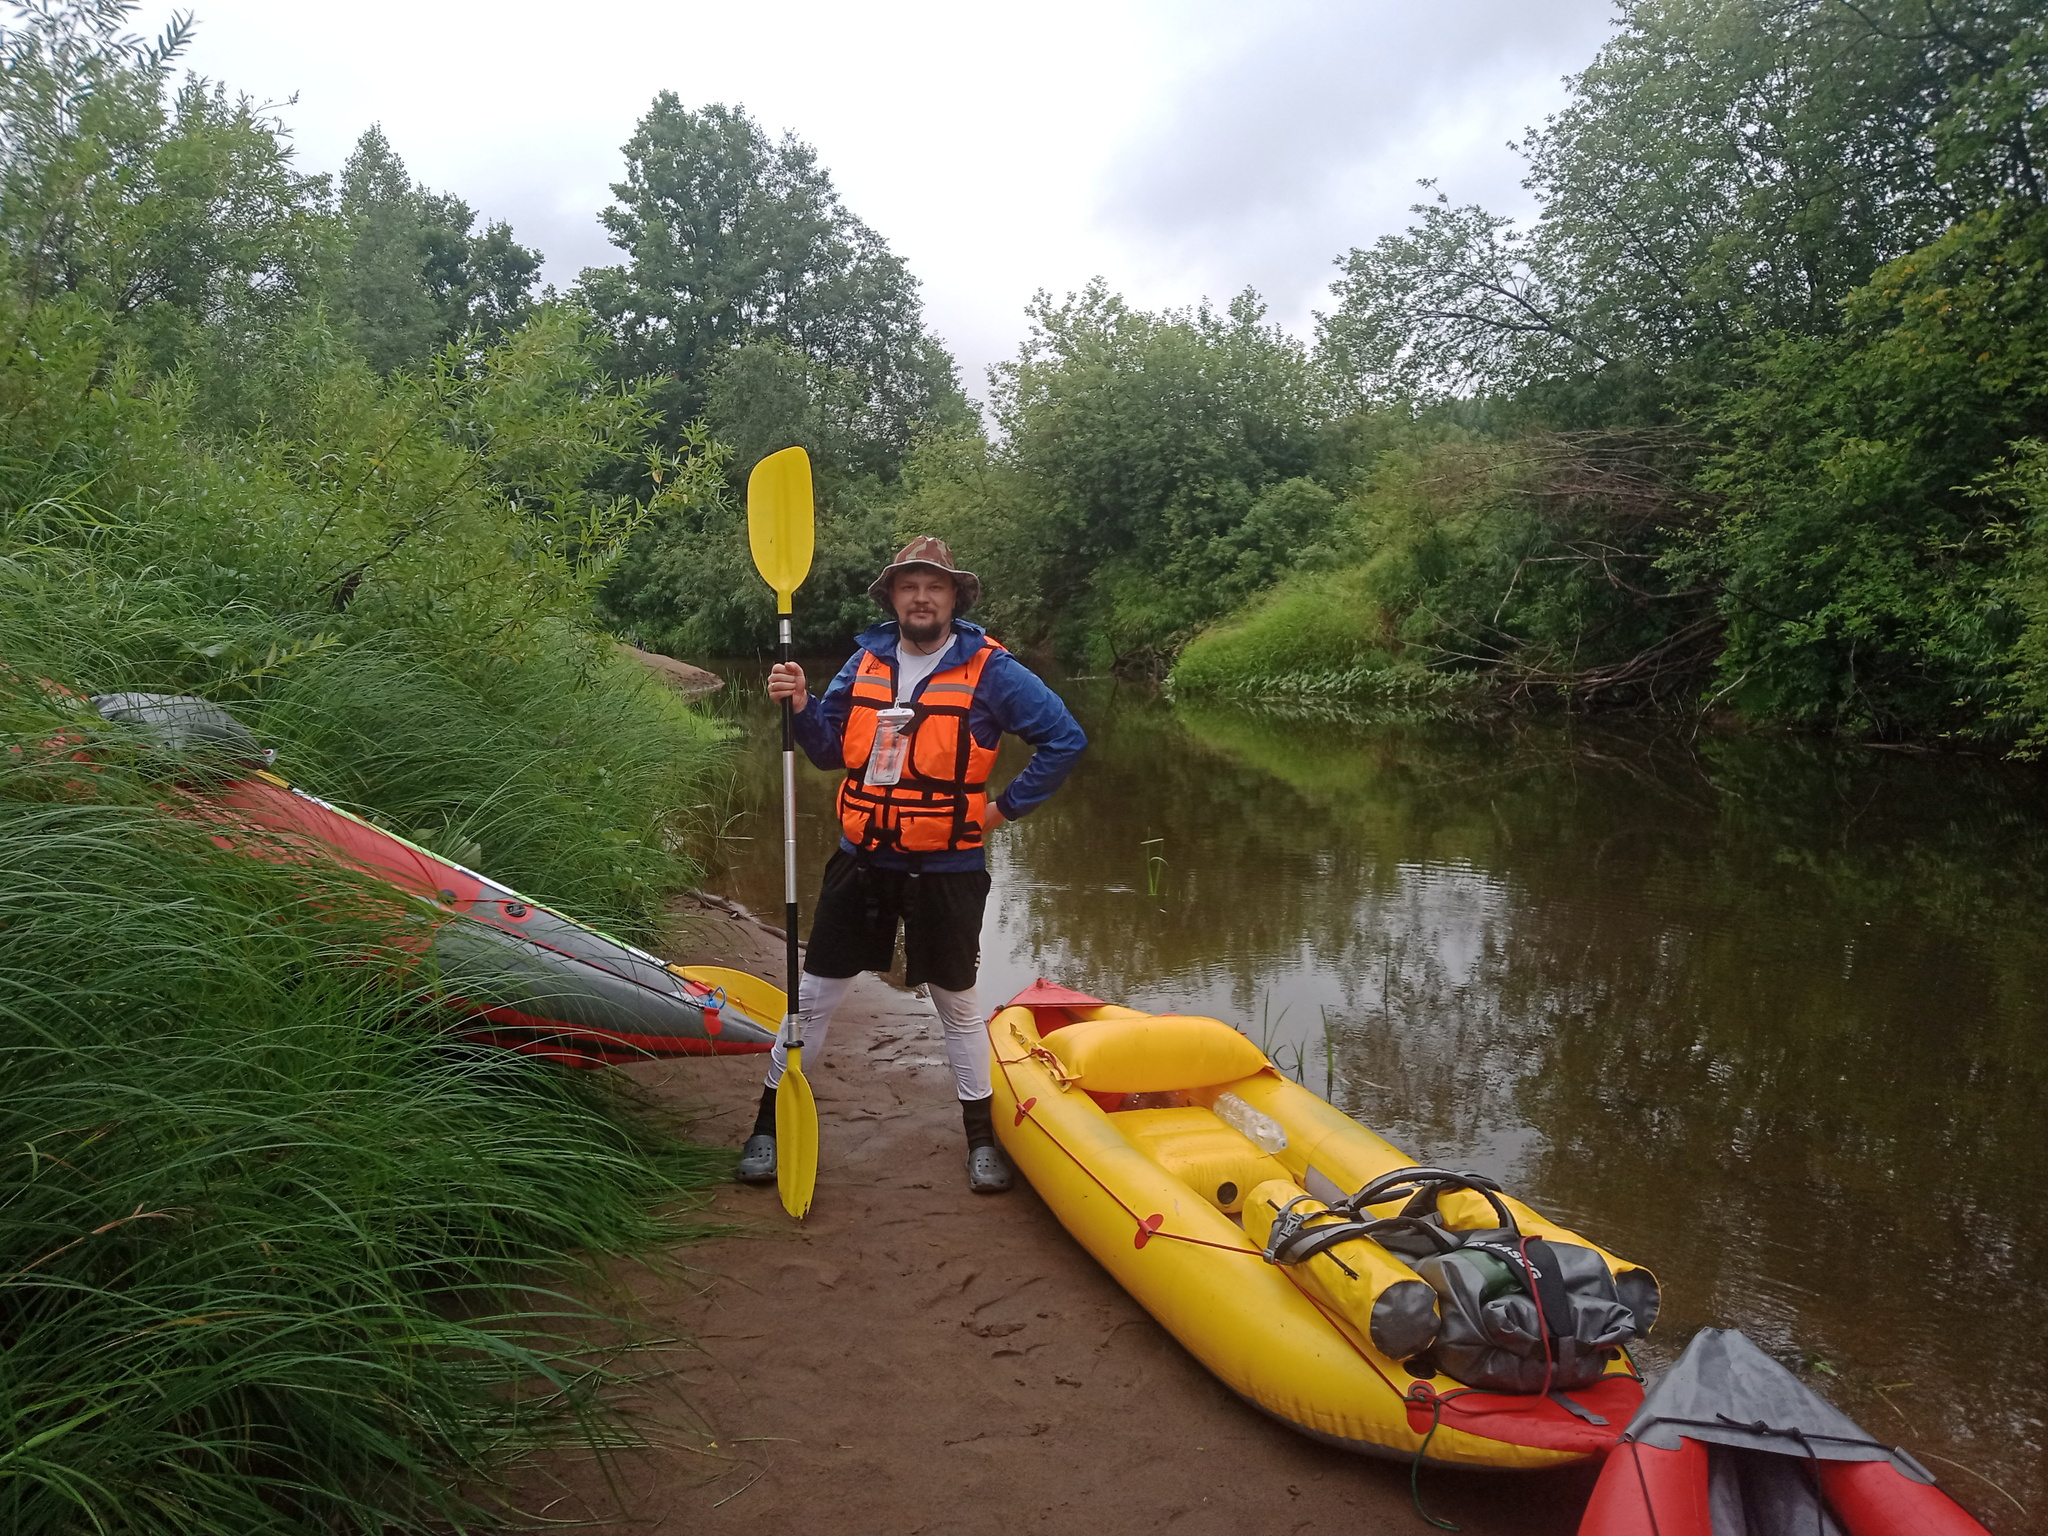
[{"left": 1579, "top": 1327, "right": 1987, "bottom": 1536}]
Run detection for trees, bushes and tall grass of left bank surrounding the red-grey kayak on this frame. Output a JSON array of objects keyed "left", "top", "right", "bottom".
[{"left": 0, "top": 4, "right": 723, "bottom": 1532}]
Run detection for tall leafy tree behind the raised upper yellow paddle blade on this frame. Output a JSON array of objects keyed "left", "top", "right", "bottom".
[{"left": 578, "top": 92, "right": 969, "bottom": 653}]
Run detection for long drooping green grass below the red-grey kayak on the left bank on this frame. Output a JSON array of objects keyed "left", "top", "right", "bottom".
[{"left": 0, "top": 724, "right": 729, "bottom": 1534}]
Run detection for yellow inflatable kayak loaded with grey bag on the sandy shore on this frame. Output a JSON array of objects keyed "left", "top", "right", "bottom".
[{"left": 989, "top": 981, "right": 1659, "bottom": 1468}]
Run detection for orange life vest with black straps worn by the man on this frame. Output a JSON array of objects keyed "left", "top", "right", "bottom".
[{"left": 840, "top": 639, "right": 1004, "bottom": 854}]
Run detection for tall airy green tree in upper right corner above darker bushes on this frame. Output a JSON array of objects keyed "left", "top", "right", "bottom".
[{"left": 1323, "top": 0, "right": 2048, "bottom": 418}]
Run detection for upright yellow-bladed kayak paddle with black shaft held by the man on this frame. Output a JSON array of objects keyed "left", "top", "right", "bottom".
[{"left": 748, "top": 438, "right": 817, "bottom": 1221}]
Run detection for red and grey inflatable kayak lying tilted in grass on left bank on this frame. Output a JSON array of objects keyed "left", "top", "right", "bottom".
[{"left": 92, "top": 694, "right": 782, "bottom": 1067}]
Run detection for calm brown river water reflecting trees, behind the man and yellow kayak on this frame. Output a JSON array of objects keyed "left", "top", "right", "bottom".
[{"left": 711, "top": 664, "right": 2048, "bottom": 1532}]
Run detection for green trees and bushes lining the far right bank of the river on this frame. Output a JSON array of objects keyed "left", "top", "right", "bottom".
[{"left": 614, "top": 0, "right": 2048, "bottom": 750}]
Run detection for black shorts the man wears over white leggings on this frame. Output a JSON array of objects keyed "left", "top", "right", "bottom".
[{"left": 803, "top": 848, "right": 989, "bottom": 991}]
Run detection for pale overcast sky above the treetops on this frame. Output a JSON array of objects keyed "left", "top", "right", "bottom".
[{"left": 137, "top": 0, "right": 1612, "bottom": 393}]
